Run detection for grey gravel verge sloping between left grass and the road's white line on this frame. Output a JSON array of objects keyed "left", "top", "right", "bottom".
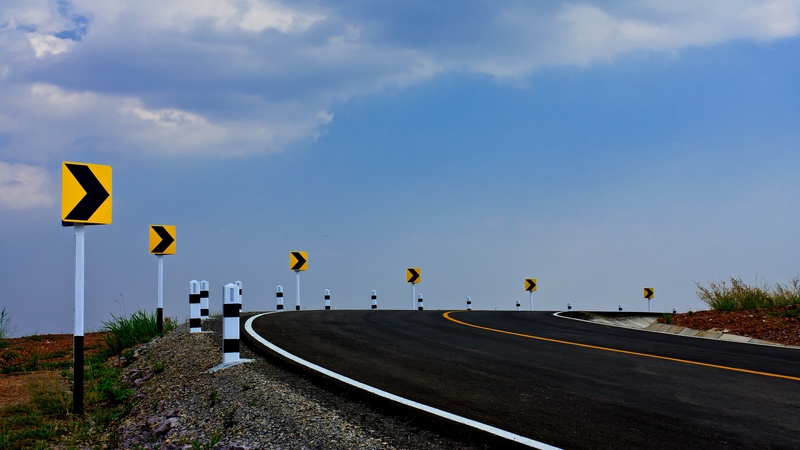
[{"left": 115, "top": 319, "right": 483, "bottom": 450}]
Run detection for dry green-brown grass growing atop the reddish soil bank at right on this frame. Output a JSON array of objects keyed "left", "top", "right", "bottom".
[{"left": 695, "top": 277, "right": 800, "bottom": 311}]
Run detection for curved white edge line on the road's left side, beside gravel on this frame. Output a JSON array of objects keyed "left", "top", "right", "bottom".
[{"left": 244, "top": 311, "right": 560, "bottom": 450}]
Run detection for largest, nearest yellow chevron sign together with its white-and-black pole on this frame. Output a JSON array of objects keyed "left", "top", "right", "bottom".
[{"left": 61, "top": 161, "right": 113, "bottom": 415}]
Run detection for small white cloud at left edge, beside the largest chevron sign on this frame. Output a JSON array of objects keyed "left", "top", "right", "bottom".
[{"left": 0, "top": 161, "right": 55, "bottom": 210}]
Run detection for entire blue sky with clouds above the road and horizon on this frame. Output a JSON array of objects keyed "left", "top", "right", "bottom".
[{"left": 0, "top": 0, "right": 800, "bottom": 335}]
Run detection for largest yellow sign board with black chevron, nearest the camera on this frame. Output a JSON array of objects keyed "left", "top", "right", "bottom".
[{"left": 61, "top": 162, "right": 112, "bottom": 225}]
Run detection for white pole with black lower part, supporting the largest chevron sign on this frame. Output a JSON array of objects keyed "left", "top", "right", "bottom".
[{"left": 72, "top": 223, "right": 86, "bottom": 415}]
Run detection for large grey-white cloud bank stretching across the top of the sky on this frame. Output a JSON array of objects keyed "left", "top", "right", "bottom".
[{"left": 0, "top": 0, "right": 800, "bottom": 162}]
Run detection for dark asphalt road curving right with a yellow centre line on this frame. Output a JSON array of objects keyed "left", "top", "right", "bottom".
[{"left": 247, "top": 310, "right": 800, "bottom": 449}]
